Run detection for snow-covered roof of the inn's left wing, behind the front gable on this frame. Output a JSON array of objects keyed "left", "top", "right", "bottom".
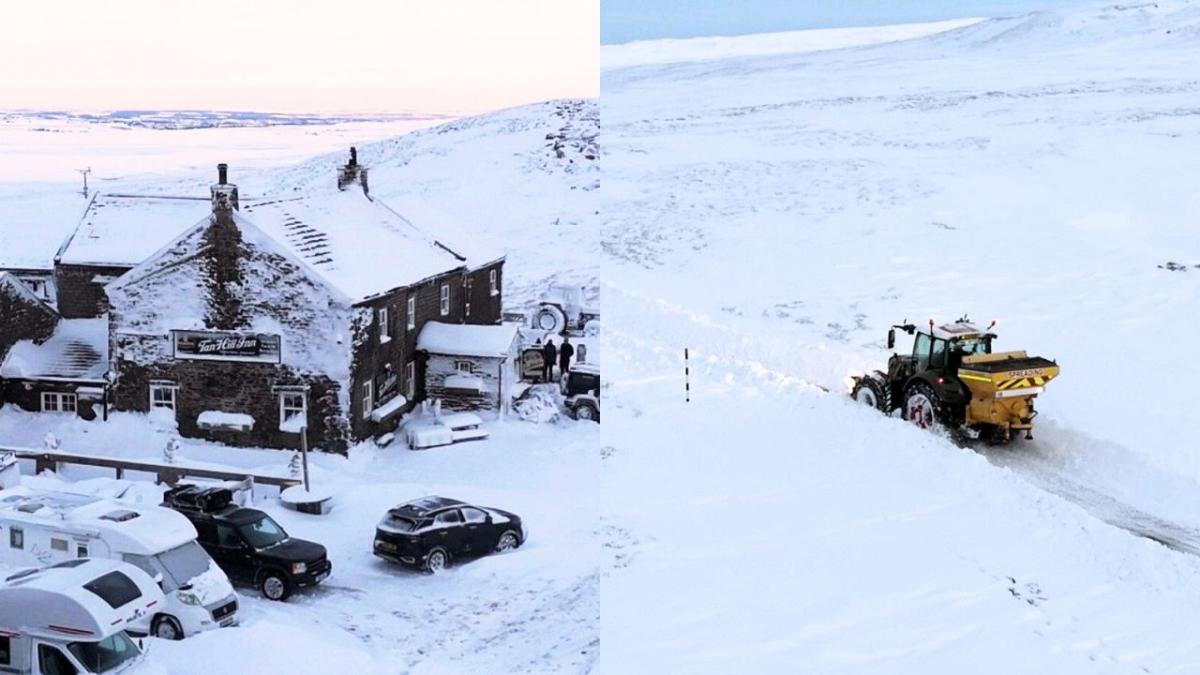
[{"left": 58, "top": 195, "right": 212, "bottom": 267}]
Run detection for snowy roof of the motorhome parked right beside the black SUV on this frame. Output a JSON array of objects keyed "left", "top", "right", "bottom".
[{"left": 0, "top": 485, "right": 196, "bottom": 555}]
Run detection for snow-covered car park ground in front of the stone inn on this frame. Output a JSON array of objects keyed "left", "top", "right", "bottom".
[{"left": 0, "top": 406, "right": 601, "bottom": 674}]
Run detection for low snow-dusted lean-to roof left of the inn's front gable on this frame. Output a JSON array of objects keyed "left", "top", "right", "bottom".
[{"left": 0, "top": 318, "right": 108, "bottom": 381}]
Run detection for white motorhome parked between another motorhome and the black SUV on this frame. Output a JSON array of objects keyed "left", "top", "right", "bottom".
[{"left": 0, "top": 485, "right": 238, "bottom": 639}]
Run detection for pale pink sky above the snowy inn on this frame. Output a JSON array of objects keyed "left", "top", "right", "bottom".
[{"left": 0, "top": 0, "right": 600, "bottom": 113}]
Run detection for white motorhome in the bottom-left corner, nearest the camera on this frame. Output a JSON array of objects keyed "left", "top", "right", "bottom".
[{"left": 0, "top": 558, "right": 164, "bottom": 675}]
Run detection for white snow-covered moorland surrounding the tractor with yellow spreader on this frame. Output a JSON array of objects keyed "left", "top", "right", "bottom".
[{"left": 599, "top": 5, "right": 1200, "bottom": 675}]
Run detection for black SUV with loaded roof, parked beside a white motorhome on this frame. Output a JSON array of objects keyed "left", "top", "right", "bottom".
[{"left": 162, "top": 485, "right": 334, "bottom": 601}]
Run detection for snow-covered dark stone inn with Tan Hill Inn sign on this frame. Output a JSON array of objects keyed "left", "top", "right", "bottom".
[{"left": 7, "top": 154, "right": 504, "bottom": 452}]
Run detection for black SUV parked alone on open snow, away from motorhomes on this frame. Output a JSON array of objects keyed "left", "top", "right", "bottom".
[{"left": 374, "top": 497, "right": 526, "bottom": 573}]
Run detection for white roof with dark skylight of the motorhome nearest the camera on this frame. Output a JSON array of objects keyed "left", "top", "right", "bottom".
[{"left": 0, "top": 557, "right": 163, "bottom": 640}]
